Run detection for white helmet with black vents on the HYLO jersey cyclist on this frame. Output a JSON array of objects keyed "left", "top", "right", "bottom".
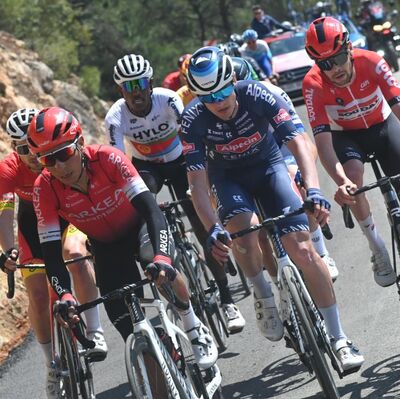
[{"left": 114, "top": 54, "right": 153, "bottom": 85}]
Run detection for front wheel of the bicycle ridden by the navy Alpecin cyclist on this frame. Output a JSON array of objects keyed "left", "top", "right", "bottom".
[{"left": 283, "top": 267, "right": 340, "bottom": 399}]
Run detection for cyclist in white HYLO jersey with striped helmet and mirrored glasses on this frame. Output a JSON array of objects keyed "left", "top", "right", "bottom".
[{"left": 105, "top": 54, "right": 245, "bottom": 333}]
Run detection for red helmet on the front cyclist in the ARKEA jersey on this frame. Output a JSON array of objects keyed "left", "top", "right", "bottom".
[{"left": 28, "top": 107, "right": 82, "bottom": 154}]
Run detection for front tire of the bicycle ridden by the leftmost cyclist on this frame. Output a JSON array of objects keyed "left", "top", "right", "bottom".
[{"left": 57, "top": 326, "right": 80, "bottom": 399}]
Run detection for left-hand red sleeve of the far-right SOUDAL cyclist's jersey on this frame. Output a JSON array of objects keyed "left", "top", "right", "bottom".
[{"left": 303, "top": 75, "right": 331, "bottom": 136}]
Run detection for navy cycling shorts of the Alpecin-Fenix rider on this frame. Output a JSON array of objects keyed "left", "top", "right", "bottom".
[{"left": 209, "top": 163, "right": 309, "bottom": 236}]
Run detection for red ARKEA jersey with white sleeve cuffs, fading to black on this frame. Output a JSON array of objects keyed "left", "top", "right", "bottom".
[{"left": 33, "top": 145, "right": 148, "bottom": 243}]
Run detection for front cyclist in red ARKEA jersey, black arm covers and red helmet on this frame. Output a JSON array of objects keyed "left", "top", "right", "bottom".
[{"left": 28, "top": 107, "right": 218, "bottom": 368}]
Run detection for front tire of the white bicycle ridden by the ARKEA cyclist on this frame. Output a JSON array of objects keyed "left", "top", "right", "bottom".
[{"left": 125, "top": 334, "right": 190, "bottom": 399}]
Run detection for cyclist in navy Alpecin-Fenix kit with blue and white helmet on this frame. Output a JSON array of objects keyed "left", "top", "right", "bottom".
[{"left": 181, "top": 47, "right": 364, "bottom": 370}]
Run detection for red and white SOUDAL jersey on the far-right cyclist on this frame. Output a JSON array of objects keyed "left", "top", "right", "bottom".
[{"left": 303, "top": 49, "right": 400, "bottom": 135}]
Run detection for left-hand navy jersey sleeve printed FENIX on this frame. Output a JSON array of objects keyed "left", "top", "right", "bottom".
[{"left": 181, "top": 102, "right": 207, "bottom": 172}]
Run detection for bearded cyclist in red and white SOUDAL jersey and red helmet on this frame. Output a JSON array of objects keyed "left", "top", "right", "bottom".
[{"left": 303, "top": 17, "right": 400, "bottom": 287}]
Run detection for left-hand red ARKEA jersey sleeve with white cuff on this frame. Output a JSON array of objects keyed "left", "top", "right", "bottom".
[{"left": 32, "top": 175, "right": 61, "bottom": 244}]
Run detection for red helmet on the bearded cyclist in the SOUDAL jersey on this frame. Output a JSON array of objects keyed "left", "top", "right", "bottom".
[{"left": 305, "top": 17, "right": 349, "bottom": 60}]
